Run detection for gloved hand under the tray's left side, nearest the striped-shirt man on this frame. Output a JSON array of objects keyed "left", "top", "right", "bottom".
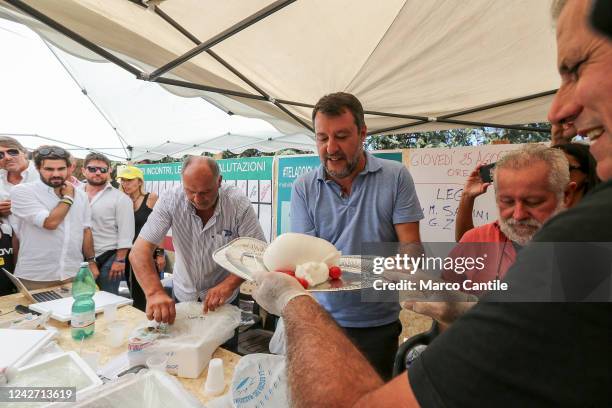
[{"left": 253, "top": 272, "right": 311, "bottom": 316}]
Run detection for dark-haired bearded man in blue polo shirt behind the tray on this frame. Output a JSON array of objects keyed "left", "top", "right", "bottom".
[{"left": 290, "top": 92, "right": 423, "bottom": 378}]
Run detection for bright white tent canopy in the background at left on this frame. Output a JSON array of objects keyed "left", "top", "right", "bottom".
[{"left": 0, "top": 20, "right": 314, "bottom": 160}]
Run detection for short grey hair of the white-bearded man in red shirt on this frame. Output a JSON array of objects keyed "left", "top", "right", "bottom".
[{"left": 493, "top": 144, "right": 570, "bottom": 199}]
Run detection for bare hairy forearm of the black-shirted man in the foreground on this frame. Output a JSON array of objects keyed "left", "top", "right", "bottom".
[{"left": 283, "top": 296, "right": 383, "bottom": 407}]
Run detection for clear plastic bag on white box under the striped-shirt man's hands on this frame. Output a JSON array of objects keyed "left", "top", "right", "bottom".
[{"left": 128, "top": 302, "right": 240, "bottom": 378}]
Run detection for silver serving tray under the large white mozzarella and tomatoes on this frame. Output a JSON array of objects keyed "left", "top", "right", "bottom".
[{"left": 213, "top": 237, "right": 363, "bottom": 292}]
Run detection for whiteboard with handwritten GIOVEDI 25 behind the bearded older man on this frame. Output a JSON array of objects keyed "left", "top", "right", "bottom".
[{"left": 404, "top": 144, "right": 522, "bottom": 242}]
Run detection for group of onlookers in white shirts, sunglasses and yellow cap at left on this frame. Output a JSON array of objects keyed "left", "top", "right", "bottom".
[{"left": 0, "top": 142, "right": 165, "bottom": 311}]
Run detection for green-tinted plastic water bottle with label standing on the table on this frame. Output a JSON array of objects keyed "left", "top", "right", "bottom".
[{"left": 70, "top": 262, "right": 96, "bottom": 340}]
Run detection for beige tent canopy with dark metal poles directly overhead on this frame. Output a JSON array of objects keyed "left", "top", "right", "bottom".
[{"left": 0, "top": 0, "right": 558, "bottom": 147}]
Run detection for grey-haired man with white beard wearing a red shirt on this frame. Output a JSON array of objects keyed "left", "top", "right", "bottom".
[{"left": 442, "top": 145, "right": 576, "bottom": 290}]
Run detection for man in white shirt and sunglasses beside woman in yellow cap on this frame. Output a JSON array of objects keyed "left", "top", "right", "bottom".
[{"left": 81, "top": 153, "right": 134, "bottom": 294}]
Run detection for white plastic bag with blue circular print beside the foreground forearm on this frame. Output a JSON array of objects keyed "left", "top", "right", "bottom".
[{"left": 231, "top": 354, "right": 291, "bottom": 408}]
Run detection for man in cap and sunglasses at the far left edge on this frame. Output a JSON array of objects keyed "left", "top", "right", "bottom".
[{"left": 0, "top": 136, "right": 38, "bottom": 217}]
